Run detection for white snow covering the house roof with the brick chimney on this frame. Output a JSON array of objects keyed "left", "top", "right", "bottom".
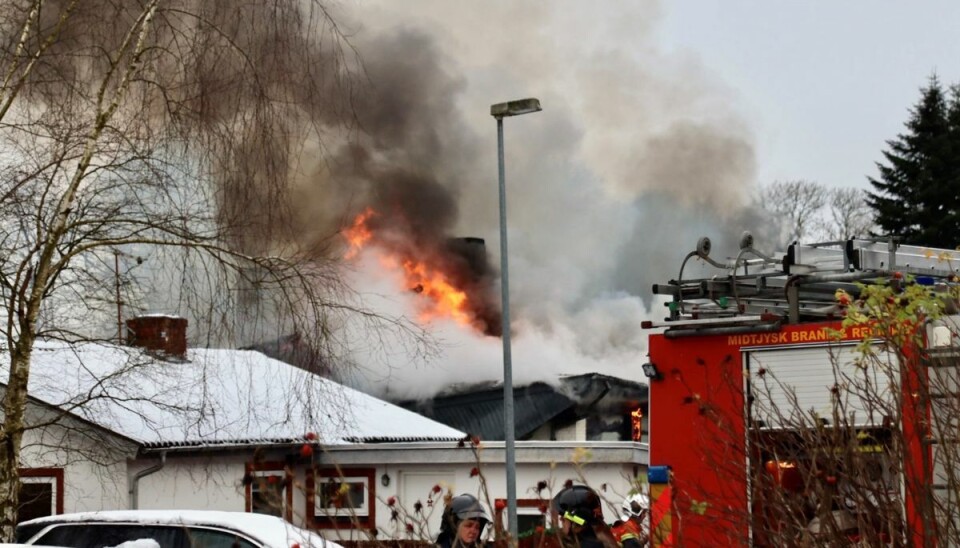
[{"left": 0, "top": 342, "right": 465, "bottom": 446}]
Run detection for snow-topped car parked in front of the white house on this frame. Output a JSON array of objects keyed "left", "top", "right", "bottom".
[{"left": 17, "top": 510, "right": 341, "bottom": 548}]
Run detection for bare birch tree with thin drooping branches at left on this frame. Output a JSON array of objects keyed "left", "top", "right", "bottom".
[{"left": 0, "top": 0, "right": 404, "bottom": 541}]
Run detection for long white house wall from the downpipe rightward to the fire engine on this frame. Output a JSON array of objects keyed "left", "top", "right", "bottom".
[{"left": 124, "top": 442, "right": 646, "bottom": 540}]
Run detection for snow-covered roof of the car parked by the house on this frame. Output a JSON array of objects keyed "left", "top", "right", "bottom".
[{"left": 20, "top": 510, "right": 340, "bottom": 548}]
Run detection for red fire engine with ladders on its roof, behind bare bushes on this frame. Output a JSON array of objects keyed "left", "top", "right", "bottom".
[{"left": 643, "top": 233, "right": 960, "bottom": 546}]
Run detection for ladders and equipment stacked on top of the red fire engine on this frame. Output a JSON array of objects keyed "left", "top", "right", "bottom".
[{"left": 644, "top": 232, "right": 960, "bottom": 336}]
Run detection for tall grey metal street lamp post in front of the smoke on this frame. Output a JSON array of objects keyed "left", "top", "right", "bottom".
[{"left": 490, "top": 98, "right": 541, "bottom": 543}]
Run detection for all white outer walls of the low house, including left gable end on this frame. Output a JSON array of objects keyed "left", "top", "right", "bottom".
[{"left": 13, "top": 409, "right": 647, "bottom": 540}]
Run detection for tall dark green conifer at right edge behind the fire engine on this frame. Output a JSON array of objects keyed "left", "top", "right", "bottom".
[{"left": 867, "top": 75, "right": 960, "bottom": 248}]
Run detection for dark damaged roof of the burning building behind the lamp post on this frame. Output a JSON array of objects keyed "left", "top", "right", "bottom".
[{"left": 399, "top": 373, "right": 648, "bottom": 440}]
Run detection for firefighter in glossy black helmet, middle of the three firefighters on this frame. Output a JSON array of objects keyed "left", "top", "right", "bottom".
[{"left": 553, "top": 485, "right": 628, "bottom": 548}]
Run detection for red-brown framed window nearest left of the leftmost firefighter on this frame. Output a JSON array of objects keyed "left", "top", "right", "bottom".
[{"left": 307, "top": 468, "right": 376, "bottom": 528}]
